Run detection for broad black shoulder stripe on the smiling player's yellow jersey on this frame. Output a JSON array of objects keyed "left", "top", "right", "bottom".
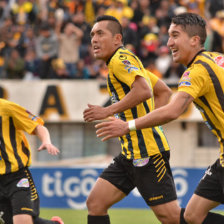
[{"left": 195, "top": 60, "right": 224, "bottom": 111}]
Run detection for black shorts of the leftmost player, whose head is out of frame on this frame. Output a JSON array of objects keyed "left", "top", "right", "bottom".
[{"left": 0, "top": 168, "right": 40, "bottom": 224}]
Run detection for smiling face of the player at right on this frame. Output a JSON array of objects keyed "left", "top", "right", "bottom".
[{"left": 167, "top": 23, "right": 195, "bottom": 65}]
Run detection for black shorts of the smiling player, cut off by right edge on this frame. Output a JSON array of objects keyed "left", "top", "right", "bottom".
[{"left": 194, "top": 159, "right": 224, "bottom": 204}]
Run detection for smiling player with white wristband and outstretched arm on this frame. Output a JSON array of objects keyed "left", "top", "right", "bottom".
[{"left": 96, "top": 13, "right": 224, "bottom": 224}]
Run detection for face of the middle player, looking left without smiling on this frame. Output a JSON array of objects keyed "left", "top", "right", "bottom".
[{"left": 90, "top": 21, "right": 117, "bottom": 61}]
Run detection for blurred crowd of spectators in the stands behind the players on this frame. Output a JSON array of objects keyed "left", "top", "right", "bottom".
[{"left": 0, "top": 0, "right": 224, "bottom": 80}]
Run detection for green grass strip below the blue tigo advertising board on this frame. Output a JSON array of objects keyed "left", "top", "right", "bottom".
[{"left": 40, "top": 209, "right": 224, "bottom": 224}]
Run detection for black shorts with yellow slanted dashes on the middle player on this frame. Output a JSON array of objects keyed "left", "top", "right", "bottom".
[{"left": 100, "top": 151, "right": 177, "bottom": 206}]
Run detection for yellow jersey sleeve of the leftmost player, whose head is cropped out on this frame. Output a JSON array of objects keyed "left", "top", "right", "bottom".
[{"left": 9, "top": 103, "right": 44, "bottom": 134}]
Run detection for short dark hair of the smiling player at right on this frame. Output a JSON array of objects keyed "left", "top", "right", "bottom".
[{"left": 172, "top": 12, "right": 207, "bottom": 46}]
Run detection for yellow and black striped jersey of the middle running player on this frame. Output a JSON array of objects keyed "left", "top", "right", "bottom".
[{"left": 107, "top": 47, "right": 169, "bottom": 159}]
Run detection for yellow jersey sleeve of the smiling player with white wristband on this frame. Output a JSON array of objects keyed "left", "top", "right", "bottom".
[{"left": 178, "top": 66, "right": 209, "bottom": 99}]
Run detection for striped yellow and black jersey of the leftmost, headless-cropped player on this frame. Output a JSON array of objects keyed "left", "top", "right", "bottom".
[{"left": 0, "top": 99, "right": 44, "bottom": 175}]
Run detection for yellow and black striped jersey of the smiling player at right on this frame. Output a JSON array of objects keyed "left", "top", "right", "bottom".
[{"left": 178, "top": 51, "right": 224, "bottom": 166}]
